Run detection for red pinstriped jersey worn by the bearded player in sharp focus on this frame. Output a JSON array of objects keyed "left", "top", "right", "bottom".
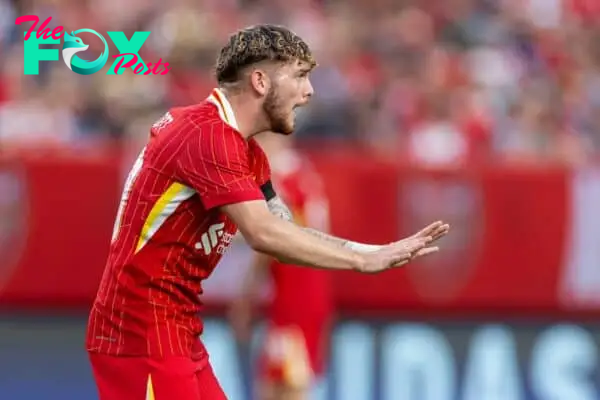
[{"left": 86, "top": 89, "right": 270, "bottom": 356}]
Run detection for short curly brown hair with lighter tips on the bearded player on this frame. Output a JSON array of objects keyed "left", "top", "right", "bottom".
[{"left": 215, "top": 24, "right": 317, "bottom": 84}]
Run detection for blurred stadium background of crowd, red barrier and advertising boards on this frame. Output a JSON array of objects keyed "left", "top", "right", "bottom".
[{"left": 0, "top": 0, "right": 600, "bottom": 400}]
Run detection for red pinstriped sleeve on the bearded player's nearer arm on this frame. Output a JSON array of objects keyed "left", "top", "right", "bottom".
[{"left": 178, "top": 124, "right": 264, "bottom": 210}]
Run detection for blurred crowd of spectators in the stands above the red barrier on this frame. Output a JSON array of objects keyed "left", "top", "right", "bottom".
[{"left": 0, "top": 0, "right": 600, "bottom": 165}]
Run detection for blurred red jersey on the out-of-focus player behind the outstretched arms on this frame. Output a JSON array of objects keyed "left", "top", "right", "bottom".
[{"left": 268, "top": 151, "right": 333, "bottom": 366}]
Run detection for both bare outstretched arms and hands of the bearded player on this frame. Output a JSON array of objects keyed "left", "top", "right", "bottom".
[{"left": 220, "top": 184, "right": 448, "bottom": 273}]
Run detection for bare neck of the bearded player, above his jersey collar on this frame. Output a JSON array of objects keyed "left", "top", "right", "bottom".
[{"left": 220, "top": 88, "right": 268, "bottom": 140}]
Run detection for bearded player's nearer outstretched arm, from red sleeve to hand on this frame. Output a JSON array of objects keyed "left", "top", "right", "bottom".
[{"left": 175, "top": 115, "right": 446, "bottom": 273}]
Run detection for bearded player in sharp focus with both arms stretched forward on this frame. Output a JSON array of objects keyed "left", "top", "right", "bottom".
[{"left": 86, "top": 25, "right": 448, "bottom": 400}]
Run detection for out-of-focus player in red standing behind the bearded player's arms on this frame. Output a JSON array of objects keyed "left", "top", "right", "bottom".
[{"left": 230, "top": 133, "right": 333, "bottom": 400}]
